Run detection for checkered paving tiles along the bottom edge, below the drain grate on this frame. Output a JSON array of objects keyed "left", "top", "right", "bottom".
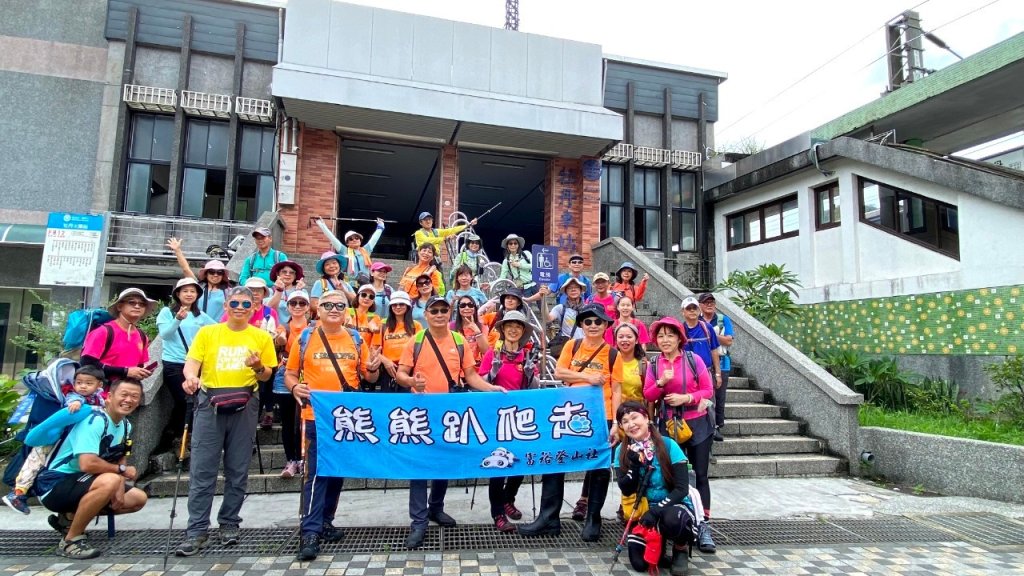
[{"left": 0, "top": 542, "right": 1024, "bottom": 576}]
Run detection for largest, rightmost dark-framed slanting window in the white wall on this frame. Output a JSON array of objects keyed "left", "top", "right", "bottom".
[{"left": 859, "top": 178, "right": 959, "bottom": 255}]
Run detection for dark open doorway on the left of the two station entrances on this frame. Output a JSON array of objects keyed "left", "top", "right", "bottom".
[{"left": 335, "top": 139, "right": 440, "bottom": 258}]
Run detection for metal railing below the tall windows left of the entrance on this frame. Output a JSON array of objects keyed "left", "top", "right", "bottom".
[{"left": 106, "top": 212, "right": 253, "bottom": 261}]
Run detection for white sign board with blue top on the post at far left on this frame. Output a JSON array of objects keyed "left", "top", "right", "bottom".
[{"left": 39, "top": 212, "right": 103, "bottom": 286}]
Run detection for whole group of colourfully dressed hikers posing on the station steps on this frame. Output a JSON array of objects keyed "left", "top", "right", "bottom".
[{"left": 4, "top": 212, "right": 733, "bottom": 570}]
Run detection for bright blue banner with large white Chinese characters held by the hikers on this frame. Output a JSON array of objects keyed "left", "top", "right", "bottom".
[{"left": 311, "top": 386, "right": 611, "bottom": 480}]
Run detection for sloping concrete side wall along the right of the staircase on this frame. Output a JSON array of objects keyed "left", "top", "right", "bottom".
[{"left": 593, "top": 238, "right": 864, "bottom": 462}]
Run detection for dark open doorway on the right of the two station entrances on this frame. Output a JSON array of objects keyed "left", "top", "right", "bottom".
[{"left": 459, "top": 150, "right": 548, "bottom": 261}]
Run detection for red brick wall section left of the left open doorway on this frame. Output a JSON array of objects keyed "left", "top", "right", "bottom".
[{"left": 280, "top": 125, "right": 340, "bottom": 254}]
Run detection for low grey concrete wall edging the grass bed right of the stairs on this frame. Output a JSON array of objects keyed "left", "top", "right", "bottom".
[{"left": 850, "top": 427, "right": 1024, "bottom": 502}]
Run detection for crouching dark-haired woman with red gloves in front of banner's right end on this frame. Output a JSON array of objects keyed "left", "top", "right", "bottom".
[{"left": 612, "top": 401, "right": 695, "bottom": 574}]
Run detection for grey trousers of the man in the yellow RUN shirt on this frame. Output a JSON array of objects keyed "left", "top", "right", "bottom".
[{"left": 185, "top": 390, "right": 259, "bottom": 538}]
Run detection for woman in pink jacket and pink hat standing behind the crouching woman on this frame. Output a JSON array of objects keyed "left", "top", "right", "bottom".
[{"left": 643, "top": 317, "right": 715, "bottom": 552}]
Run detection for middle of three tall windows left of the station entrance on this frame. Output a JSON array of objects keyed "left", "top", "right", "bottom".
[{"left": 181, "top": 120, "right": 233, "bottom": 218}]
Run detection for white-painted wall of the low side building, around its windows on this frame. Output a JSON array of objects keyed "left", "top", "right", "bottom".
[{"left": 715, "top": 160, "right": 1024, "bottom": 303}]
